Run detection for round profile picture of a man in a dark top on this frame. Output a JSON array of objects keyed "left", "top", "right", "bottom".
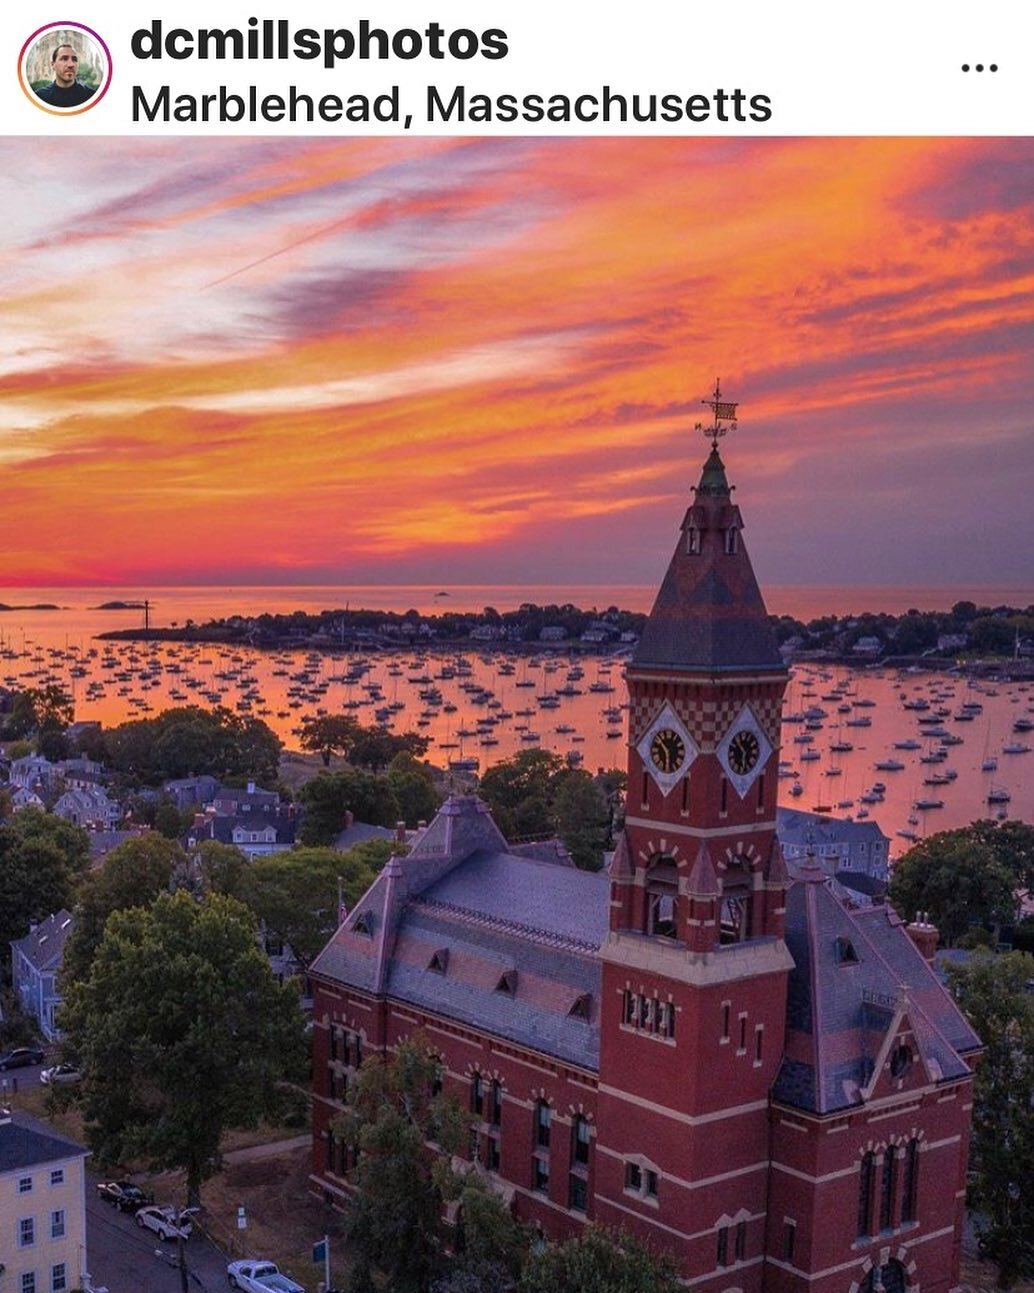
[{"left": 18, "top": 22, "right": 111, "bottom": 116}]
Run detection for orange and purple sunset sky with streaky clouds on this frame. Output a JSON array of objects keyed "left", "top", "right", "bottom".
[{"left": 0, "top": 138, "right": 1034, "bottom": 587}]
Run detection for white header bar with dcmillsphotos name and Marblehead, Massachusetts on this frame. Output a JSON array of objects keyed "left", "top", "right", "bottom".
[{"left": 0, "top": 0, "right": 1034, "bottom": 136}]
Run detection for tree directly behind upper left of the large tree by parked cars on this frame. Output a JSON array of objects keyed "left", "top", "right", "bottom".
[{"left": 62, "top": 831, "right": 186, "bottom": 983}]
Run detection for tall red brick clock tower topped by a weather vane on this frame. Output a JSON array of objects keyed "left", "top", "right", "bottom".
[{"left": 596, "top": 383, "right": 792, "bottom": 1289}]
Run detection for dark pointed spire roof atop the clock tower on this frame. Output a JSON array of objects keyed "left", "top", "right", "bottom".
[{"left": 632, "top": 449, "right": 785, "bottom": 672}]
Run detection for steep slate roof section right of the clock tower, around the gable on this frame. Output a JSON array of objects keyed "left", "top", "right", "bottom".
[{"left": 773, "top": 868, "right": 980, "bottom": 1113}]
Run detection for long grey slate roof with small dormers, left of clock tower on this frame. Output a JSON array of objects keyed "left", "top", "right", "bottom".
[{"left": 310, "top": 795, "right": 610, "bottom": 1069}]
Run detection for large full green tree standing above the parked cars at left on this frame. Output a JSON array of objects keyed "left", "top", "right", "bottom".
[{"left": 61, "top": 890, "right": 305, "bottom": 1202}]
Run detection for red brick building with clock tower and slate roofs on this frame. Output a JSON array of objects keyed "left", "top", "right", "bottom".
[{"left": 310, "top": 421, "right": 980, "bottom": 1293}]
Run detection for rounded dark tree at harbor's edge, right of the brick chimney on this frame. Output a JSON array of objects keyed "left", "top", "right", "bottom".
[{"left": 889, "top": 829, "right": 1016, "bottom": 945}]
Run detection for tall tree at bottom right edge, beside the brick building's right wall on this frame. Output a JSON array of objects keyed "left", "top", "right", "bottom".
[{"left": 947, "top": 952, "right": 1034, "bottom": 1288}]
